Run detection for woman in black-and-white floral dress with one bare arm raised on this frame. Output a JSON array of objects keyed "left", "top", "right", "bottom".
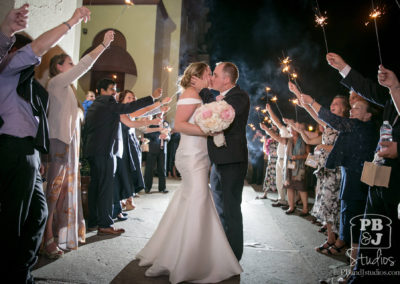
[{"left": 289, "top": 82, "right": 346, "bottom": 253}]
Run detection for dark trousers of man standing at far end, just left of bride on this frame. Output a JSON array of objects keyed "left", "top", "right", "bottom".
[{"left": 144, "top": 151, "right": 166, "bottom": 192}]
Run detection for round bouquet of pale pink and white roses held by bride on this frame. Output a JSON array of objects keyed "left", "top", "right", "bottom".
[{"left": 194, "top": 100, "right": 235, "bottom": 147}]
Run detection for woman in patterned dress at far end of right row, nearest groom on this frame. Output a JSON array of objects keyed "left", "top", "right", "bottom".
[{"left": 256, "top": 125, "right": 278, "bottom": 199}]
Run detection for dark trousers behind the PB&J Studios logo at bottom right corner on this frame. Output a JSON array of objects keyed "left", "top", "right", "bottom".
[{"left": 348, "top": 187, "right": 400, "bottom": 283}]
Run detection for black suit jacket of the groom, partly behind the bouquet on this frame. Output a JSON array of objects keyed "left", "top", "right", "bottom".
[{"left": 200, "top": 85, "right": 250, "bottom": 164}]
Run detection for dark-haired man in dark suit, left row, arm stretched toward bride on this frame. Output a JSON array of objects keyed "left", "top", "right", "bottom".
[{"left": 83, "top": 79, "right": 161, "bottom": 235}]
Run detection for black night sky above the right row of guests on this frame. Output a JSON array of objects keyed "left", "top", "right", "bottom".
[{"left": 207, "top": 0, "right": 400, "bottom": 128}]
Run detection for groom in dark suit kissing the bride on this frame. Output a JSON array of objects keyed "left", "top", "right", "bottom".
[{"left": 191, "top": 62, "right": 250, "bottom": 260}]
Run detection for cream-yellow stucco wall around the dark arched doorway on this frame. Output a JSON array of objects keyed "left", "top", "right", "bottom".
[{"left": 78, "top": 0, "right": 182, "bottom": 107}]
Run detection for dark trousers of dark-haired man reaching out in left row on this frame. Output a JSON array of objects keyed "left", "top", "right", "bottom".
[{"left": 88, "top": 156, "right": 116, "bottom": 228}]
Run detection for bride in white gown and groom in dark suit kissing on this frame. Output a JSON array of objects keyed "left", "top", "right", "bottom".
[{"left": 136, "top": 62, "right": 250, "bottom": 283}]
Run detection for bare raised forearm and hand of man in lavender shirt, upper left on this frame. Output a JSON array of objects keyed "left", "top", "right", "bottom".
[{"left": 31, "top": 7, "right": 90, "bottom": 56}]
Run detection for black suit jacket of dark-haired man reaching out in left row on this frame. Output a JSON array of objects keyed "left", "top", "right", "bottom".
[{"left": 82, "top": 95, "right": 153, "bottom": 158}]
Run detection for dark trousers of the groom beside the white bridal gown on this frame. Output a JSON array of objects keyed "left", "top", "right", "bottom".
[{"left": 210, "top": 163, "right": 247, "bottom": 260}]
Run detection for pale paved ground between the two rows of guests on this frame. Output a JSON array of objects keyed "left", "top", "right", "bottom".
[{"left": 33, "top": 179, "right": 347, "bottom": 284}]
